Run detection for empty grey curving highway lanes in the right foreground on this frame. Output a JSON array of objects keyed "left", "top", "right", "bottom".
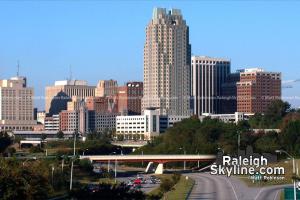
[{"left": 185, "top": 173, "right": 291, "bottom": 200}]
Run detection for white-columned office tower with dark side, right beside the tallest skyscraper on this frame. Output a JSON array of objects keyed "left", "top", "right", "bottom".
[{"left": 191, "top": 56, "right": 230, "bottom": 116}]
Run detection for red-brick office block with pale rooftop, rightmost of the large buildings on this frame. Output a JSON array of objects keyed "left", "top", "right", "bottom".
[{"left": 237, "top": 68, "right": 281, "bottom": 113}]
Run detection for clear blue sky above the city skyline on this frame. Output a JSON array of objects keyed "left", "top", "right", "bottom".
[{"left": 0, "top": 0, "right": 300, "bottom": 109}]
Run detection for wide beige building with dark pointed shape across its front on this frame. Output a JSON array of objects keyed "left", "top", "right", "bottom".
[{"left": 45, "top": 80, "right": 96, "bottom": 116}]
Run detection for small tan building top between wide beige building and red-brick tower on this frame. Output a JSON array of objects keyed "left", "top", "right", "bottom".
[{"left": 95, "top": 79, "right": 118, "bottom": 97}]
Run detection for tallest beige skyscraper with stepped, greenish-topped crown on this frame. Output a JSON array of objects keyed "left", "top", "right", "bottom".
[{"left": 142, "top": 8, "right": 191, "bottom": 116}]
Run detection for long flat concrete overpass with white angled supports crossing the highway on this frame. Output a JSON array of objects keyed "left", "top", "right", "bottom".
[{"left": 80, "top": 154, "right": 216, "bottom": 174}]
